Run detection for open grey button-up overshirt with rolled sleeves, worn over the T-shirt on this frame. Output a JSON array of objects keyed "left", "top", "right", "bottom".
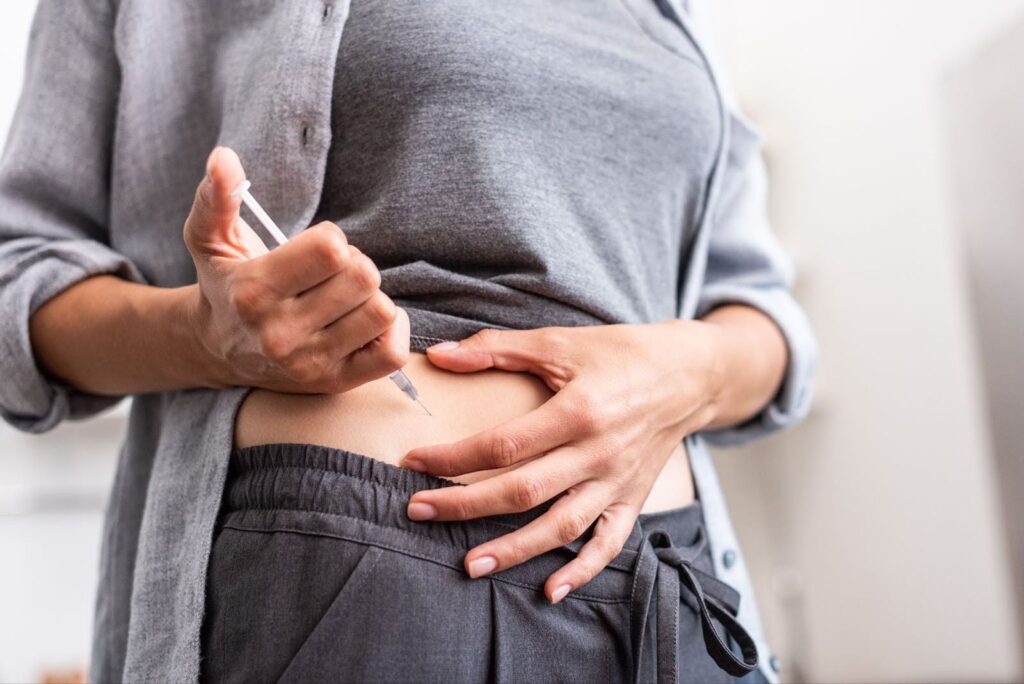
[{"left": 0, "top": 0, "right": 816, "bottom": 681}]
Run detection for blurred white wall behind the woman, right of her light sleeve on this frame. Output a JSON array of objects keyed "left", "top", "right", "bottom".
[{"left": 719, "top": 0, "right": 1022, "bottom": 682}]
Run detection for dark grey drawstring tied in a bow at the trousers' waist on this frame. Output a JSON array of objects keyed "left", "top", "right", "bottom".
[{"left": 630, "top": 529, "right": 758, "bottom": 684}]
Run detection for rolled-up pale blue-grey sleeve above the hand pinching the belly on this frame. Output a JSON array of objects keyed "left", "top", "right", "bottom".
[{"left": 696, "top": 112, "right": 818, "bottom": 445}]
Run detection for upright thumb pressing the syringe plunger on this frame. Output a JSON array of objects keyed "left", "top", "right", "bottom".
[{"left": 184, "top": 147, "right": 266, "bottom": 258}]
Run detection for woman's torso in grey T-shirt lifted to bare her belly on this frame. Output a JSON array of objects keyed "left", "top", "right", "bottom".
[{"left": 236, "top": 0, "right": 719, "bottom": 511}]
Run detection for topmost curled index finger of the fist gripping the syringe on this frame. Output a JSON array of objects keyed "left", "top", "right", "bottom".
[{"left": 253, "top": 221, "right": 354, "bottom": 296}]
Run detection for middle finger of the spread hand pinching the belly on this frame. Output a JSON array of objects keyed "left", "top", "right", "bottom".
[{"left": 409, "top": 446, "right": 585, "bottom": 520}]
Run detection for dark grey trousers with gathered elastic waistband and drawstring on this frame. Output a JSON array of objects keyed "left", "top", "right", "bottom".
[{"left": 202, "top": 444, "right": 763, "bottom": 682}]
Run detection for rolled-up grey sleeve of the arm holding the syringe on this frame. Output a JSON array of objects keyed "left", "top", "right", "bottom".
[{"left": 0, "top": 0, "right": 143, "bottom": 432}]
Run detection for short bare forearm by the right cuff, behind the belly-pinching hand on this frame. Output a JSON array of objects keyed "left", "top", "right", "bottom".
[{"left": 702, "top": 304, "right": 788, "bottom": 429}]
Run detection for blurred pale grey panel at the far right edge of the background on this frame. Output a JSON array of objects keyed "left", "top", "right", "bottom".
[{"left": 944, "top": 14, "right": 1024, "bottom": 647}]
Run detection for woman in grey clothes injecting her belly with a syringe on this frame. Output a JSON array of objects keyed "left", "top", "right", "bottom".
[{"left": 0, "top": 0, "right": 815, "bottom": 681}]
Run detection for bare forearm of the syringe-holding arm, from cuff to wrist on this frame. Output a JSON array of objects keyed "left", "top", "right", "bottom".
[{"left": 30, "top": 275, "right": 222, "bottom": 395}]
